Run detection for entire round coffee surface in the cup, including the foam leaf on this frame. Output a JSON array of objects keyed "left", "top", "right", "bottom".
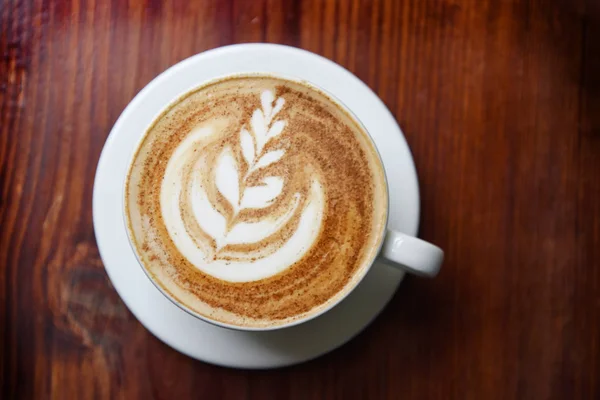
[{"left": 125, "top": 75, "right": 387, "bottom": 327}]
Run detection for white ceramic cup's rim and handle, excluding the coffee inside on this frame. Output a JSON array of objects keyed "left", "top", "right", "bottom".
[{"left": 123, "top": 72, "right": 444, "bottom": 331}]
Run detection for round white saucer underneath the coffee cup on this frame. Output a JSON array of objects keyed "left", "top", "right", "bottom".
[{"left": 93, "top": 44, "right": 419, "bottom": 368}]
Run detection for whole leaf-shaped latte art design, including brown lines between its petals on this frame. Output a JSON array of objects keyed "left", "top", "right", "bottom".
[{"left": 160, "top": 90, "right": 324, "bottom": 282}]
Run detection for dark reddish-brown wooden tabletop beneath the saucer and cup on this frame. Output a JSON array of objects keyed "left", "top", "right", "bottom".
[{"left": 0, "top": 0, "right": 600, "bottom": 400}]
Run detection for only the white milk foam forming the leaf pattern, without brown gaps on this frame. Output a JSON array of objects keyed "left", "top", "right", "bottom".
[{"left": 160, "top": 97, "right": 324, "bottom": 282}]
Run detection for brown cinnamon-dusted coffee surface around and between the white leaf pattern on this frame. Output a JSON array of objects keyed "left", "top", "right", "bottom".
[{"left": 126, "top": 75, "right": 387, "bottom": 327}]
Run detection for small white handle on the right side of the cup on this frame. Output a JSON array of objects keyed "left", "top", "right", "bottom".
[{"left": 379, "top": 229, "right": 444, "bottom": 278}]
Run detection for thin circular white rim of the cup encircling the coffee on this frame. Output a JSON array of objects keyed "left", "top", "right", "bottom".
[{"left": 121, "top": 71, "right": 390, "bottom": 332}]
